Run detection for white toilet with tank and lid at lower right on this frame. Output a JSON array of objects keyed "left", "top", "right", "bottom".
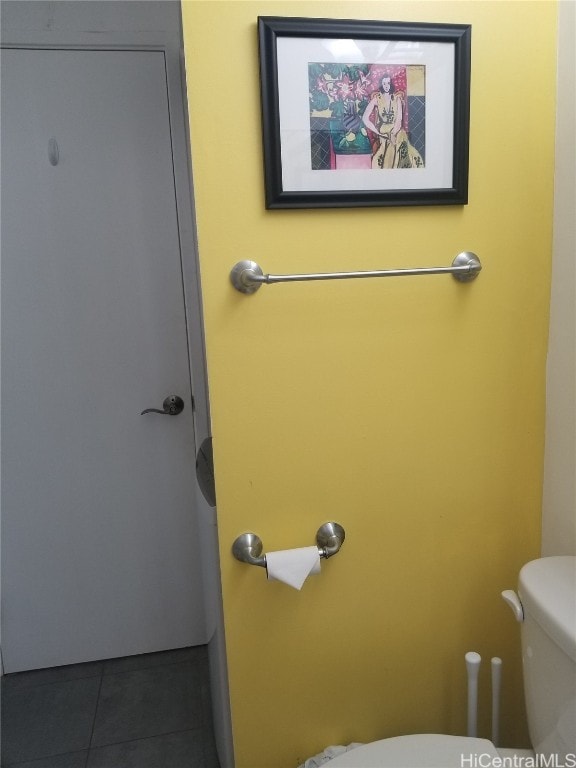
[{"left": 327, "top": 556, "right": 576, "bottom": 768}]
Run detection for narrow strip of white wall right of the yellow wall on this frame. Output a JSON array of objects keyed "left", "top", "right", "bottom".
[{"left": 542, "top": 0, "right": 576, "bottom": 555}]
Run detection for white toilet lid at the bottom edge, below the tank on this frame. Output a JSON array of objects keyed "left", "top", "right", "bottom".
[{"left": 326, "top": 733, "right": 499, "bottom": 768}]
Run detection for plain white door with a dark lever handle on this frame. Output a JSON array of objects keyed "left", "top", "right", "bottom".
[{"left": 1, "top": 49, "right": 206, "bottom": 672}]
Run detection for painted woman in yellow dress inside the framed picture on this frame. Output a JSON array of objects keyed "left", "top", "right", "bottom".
[{"left": 362, "top": 75, "right": 424, "bottom": 169}]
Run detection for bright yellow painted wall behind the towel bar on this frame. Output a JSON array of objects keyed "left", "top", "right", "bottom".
[{"left": 183, "top": 0, "right": 557, "bottom": 768}]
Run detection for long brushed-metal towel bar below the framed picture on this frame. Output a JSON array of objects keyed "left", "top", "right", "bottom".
[{"left": 230, "top": 251, "right": 482, "bottom": 293}]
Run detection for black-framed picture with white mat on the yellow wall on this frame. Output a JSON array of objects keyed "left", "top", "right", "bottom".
[{"left": 258, "top": 16, "right": 471, "bottom": 208}]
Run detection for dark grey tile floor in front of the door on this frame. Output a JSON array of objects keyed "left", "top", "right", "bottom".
[{"left": 1, "top": 646, "right": 219, "bottom": 768}]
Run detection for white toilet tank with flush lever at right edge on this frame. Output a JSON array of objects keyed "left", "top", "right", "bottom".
[{"left": 518, "top": 556, "right": 576, "bottom": 765}]
